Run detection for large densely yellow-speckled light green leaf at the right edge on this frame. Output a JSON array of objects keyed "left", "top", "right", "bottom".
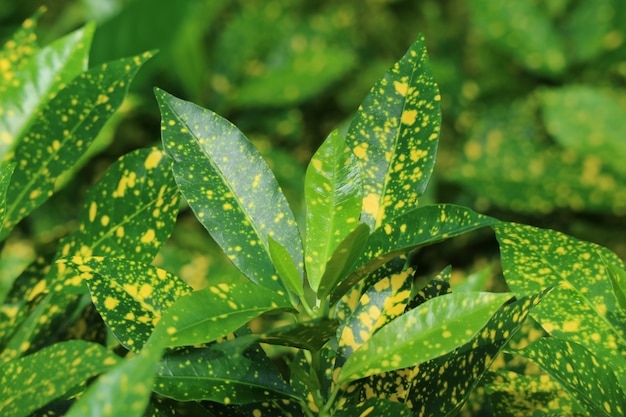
[{"left": 495, "top": 223, "right": 626, "bottom": 385}]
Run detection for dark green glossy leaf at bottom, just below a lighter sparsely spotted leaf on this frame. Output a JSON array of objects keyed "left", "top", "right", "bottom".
[{"left": 154, "top": 343, "right": 293, "bottom": 404}]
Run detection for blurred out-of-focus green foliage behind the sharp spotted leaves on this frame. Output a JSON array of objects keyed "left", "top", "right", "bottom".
[{"left": 0, "top": 0, "right": 626, "bottom": 408}]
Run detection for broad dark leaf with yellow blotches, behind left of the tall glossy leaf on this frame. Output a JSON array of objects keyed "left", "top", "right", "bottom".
[{"left": 51, "top": 148, "right": 179, "bottom": 291}]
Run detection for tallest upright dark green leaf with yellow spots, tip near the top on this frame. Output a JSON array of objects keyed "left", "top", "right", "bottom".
[{"left": 346, "top": 35, "right": 441, "bottom": 230}]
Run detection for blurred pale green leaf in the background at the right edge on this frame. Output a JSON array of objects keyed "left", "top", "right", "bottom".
[{"left": 540, "top": 85, "right": 626, "bottom": 177}]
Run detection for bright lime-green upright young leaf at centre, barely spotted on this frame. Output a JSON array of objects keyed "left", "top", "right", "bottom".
[{"left": 304, "top": 130, "right": 362, "bottom": 291}]
